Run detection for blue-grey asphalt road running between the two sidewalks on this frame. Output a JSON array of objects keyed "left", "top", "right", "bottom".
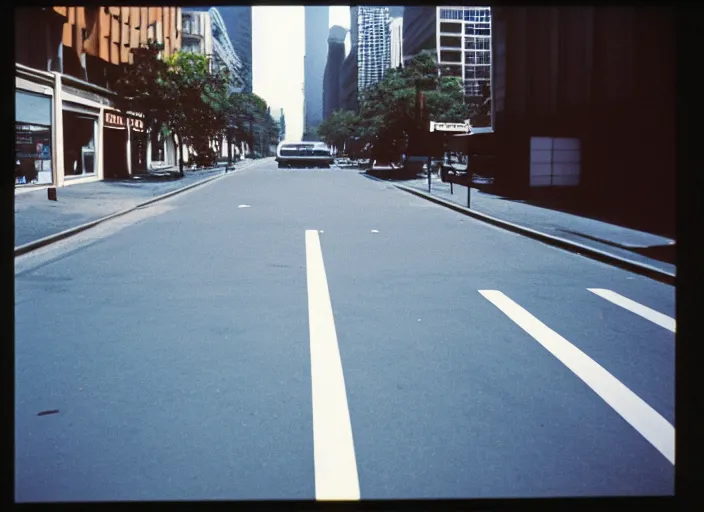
[{"left": 15, "top": 160, "right": 675, "bottom": 501}]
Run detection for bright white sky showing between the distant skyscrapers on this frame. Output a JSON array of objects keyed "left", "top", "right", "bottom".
[{"left": 252, "top": 5, "right": 350, "bottom": 140}]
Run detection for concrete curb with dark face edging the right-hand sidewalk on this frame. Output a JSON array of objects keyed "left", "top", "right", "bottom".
[{"left": 384, "top": 176, "right": 676, "bottom": 286}]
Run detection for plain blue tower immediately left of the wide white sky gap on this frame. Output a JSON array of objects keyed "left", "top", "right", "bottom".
[{"left": 183, "top": 5, "right": 252, "bottom": 92}]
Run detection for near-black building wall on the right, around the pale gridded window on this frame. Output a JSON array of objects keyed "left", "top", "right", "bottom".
[{"left": 493, "top": 7, "right": 675, "bottom": 234}]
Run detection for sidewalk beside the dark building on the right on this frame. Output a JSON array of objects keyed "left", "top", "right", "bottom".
[{"left": 391, "top": 176, "right": 676, "bottom": 280}]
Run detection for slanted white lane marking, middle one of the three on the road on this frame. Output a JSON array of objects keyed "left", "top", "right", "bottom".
[{"left": 479, "top": 290, "right": 675, "bottom": 464}]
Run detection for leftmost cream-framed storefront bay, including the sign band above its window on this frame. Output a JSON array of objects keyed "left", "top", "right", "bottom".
[{"left": 14, "top": 67, "right": 56, "bottom": 187}]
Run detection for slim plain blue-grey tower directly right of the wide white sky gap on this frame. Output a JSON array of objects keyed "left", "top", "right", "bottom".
[{"left": 303, "top": 6, "right": 330, "bottom": 139}]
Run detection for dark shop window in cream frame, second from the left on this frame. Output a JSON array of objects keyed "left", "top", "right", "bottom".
[{"left": 63, "top": 111, "right": 98, "bottom": 176}]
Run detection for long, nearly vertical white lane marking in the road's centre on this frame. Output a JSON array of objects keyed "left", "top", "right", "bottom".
[{"left": 306, "top": 230, "right": 359, "bottom": 500}]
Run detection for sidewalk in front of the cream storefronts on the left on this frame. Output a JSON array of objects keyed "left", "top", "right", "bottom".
[{"left": 15, "top": 160, "right": 254, "bottom": 247}]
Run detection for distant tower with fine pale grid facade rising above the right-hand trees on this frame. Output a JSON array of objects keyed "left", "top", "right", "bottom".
[{"left": 356, "top": 6, "right": 391, "bottom": 91}]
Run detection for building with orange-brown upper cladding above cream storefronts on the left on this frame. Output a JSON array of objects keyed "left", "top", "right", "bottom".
[{"left": 14, "top": 6, "right": 182, "bottom": 187}]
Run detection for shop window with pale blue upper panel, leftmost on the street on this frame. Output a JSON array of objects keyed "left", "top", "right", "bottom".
[{"left": 15, "top": 91, "right": 53, "bottom": 185}]
